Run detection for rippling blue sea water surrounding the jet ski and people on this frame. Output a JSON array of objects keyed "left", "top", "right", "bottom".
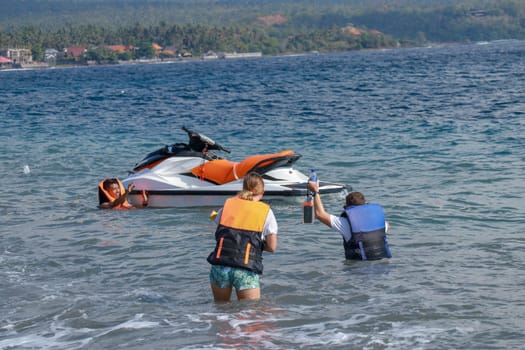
[{"left": 0, "top": 41, "right": 525, "bottom": 350}]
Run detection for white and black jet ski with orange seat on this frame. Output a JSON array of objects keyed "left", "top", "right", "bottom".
[{"left": 122, "top": 127, "right": 347, "bottom": 208}]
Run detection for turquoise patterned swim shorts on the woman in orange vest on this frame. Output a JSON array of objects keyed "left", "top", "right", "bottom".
[{"left": 210, "top": 265, "right": 260, "bottom": 291}]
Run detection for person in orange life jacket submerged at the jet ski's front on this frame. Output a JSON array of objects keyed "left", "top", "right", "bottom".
[{"left": 98, "top": 178, "right": 148, "bottom": 209}]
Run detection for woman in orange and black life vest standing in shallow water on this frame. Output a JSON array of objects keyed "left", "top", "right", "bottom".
[{"left": 207, "top": 172, "right": 278, "bottom": 302}]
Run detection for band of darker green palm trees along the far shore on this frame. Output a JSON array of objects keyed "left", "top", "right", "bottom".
[{"left": 0, "top": 23, "right": 398, "bottom": 61}]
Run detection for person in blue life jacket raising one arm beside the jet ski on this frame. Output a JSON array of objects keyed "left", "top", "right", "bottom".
[{"left": 308, "top": 181, "right": 392, "bottom": 260}]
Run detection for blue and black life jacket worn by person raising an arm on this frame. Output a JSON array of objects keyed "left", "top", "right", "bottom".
[{"left": 343, "top": 203, "right": 392, "bottom": 260}]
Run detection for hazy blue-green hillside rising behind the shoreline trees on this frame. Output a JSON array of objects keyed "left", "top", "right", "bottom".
[{"left": 0, "top": 0, "right": 525, "bottom": 42}]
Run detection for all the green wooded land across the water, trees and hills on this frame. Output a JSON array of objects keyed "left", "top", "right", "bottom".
[{"left": 0, "top": 0, "right": 525, "bottom": 59}]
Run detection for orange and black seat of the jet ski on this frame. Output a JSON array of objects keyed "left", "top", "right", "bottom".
[{"left": 191, "top": 150, "right": 301, "bottom": 185}]
